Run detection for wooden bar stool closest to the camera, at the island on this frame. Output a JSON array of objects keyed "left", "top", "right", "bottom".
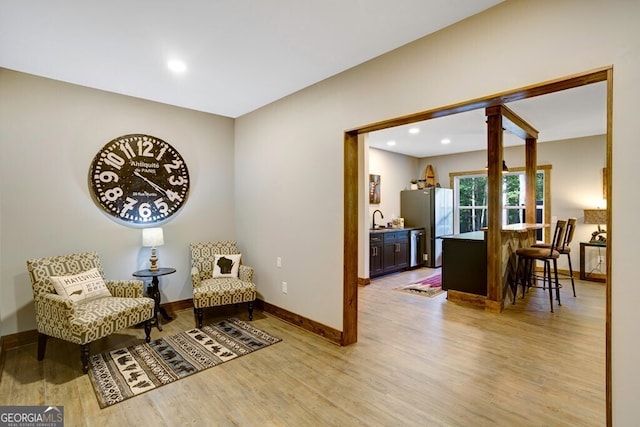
[{"left": 512, "top": 220, "right": 567, "bottom": 313}]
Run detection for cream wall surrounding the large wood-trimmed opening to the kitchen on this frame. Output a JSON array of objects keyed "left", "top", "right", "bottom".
[{"left": 236, "top": 0, "right": 640, "bottom": 425}]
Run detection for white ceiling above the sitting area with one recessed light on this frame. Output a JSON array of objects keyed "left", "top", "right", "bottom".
[{"left": 0, "top": 0, "right": 501, "bottom": 118}]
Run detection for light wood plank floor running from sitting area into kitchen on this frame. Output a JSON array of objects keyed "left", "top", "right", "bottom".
[{"left": 0, "top": 269, "right": 605, "bottom": 426}]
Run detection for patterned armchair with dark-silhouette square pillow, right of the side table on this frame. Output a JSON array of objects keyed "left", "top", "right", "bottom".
[{"left": 190, "top": 241, "right": 257, "bottom": 328}]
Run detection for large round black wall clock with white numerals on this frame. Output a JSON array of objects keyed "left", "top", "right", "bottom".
[{"left": 89, "top": 134, "right": 189, "bottom": 225}]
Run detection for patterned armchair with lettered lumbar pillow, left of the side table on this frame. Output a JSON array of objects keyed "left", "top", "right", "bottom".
[{"left": 27, "top": 252, "right": 154, "bottom": 374}]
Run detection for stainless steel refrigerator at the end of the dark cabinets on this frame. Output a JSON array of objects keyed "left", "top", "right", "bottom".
[{"left": 400, "top": 187, "right": 453, "bottom": 268}]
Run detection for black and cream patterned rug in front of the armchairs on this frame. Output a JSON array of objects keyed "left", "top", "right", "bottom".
[{"left": 89, "top": 318, "right": 281, "bottom": 408}]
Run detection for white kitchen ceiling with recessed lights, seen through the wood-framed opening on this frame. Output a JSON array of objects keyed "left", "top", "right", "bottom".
[{"left": 368, "top": 82, "right": 607, "bottom": 158}]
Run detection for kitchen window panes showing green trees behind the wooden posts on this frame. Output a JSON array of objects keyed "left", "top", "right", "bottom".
[{"left": 451, "top": 166, "right": 550, "bottom": 240}]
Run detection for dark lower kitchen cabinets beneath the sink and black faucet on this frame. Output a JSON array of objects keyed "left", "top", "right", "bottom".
[{"left": 369, "top": 229, "right": 409, "bottom": 277}]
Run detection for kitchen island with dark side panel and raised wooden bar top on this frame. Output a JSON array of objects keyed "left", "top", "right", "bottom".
[{"left": 442, "top": 223, "right": 548, "bottom": 312}]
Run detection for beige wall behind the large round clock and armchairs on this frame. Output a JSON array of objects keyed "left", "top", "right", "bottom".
[{"left": 0, "top": 69, "right": 236, "bottom": 335}]
